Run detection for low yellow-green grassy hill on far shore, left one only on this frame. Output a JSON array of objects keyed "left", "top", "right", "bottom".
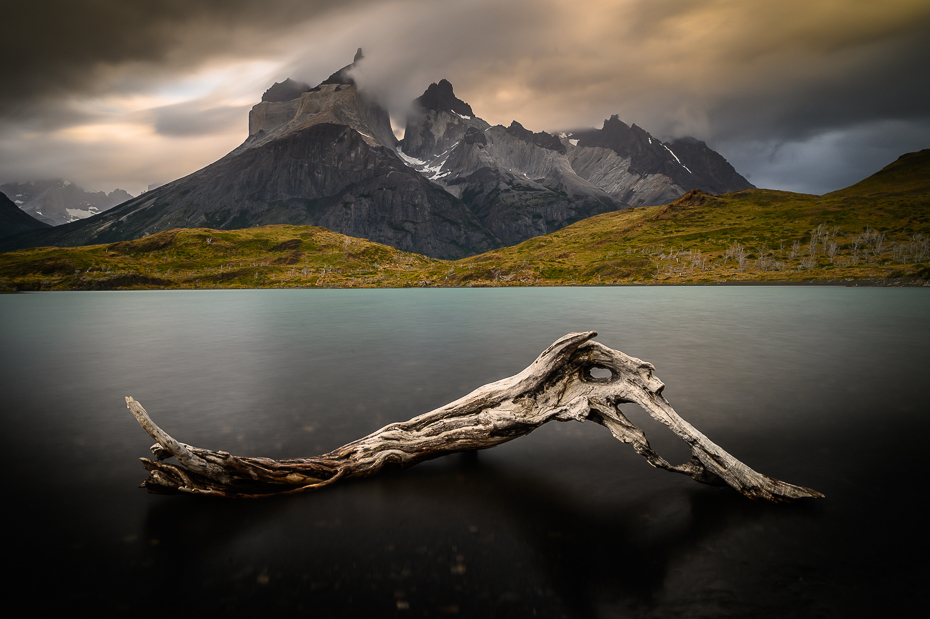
[{"left": 0, "top": 225, "right": 441, "bottom": 290}]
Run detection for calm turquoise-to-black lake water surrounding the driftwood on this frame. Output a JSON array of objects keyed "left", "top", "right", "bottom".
[{"left": 0, "top": 287, "right": 930, "bottom": 618}]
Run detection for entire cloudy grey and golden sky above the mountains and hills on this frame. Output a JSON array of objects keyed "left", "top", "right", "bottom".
[{"left": 0, "top": 0, "right": 930, "bottom": 195}]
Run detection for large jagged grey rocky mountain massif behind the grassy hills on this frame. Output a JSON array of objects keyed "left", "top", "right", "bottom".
[{"left": 2, "top": 50, "right": 752, "bottom": 258}]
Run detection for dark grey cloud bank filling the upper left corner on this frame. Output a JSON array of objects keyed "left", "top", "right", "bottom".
[{"left": 0, "top": 0, "right": 356, "bottom": 115}]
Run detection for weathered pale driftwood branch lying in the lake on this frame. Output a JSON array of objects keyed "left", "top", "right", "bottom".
[{"left": 126, "top": 331, "right": 823, "bottom": 501}]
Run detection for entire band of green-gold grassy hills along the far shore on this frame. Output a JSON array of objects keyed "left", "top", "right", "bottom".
[{"left": 0, "top": 150, "right": 930, "bottom": 290}]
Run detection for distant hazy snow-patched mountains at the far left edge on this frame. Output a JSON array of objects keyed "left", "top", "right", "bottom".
[{"left": 0, "top": 179, "right": 132, "bottom": 226}]
